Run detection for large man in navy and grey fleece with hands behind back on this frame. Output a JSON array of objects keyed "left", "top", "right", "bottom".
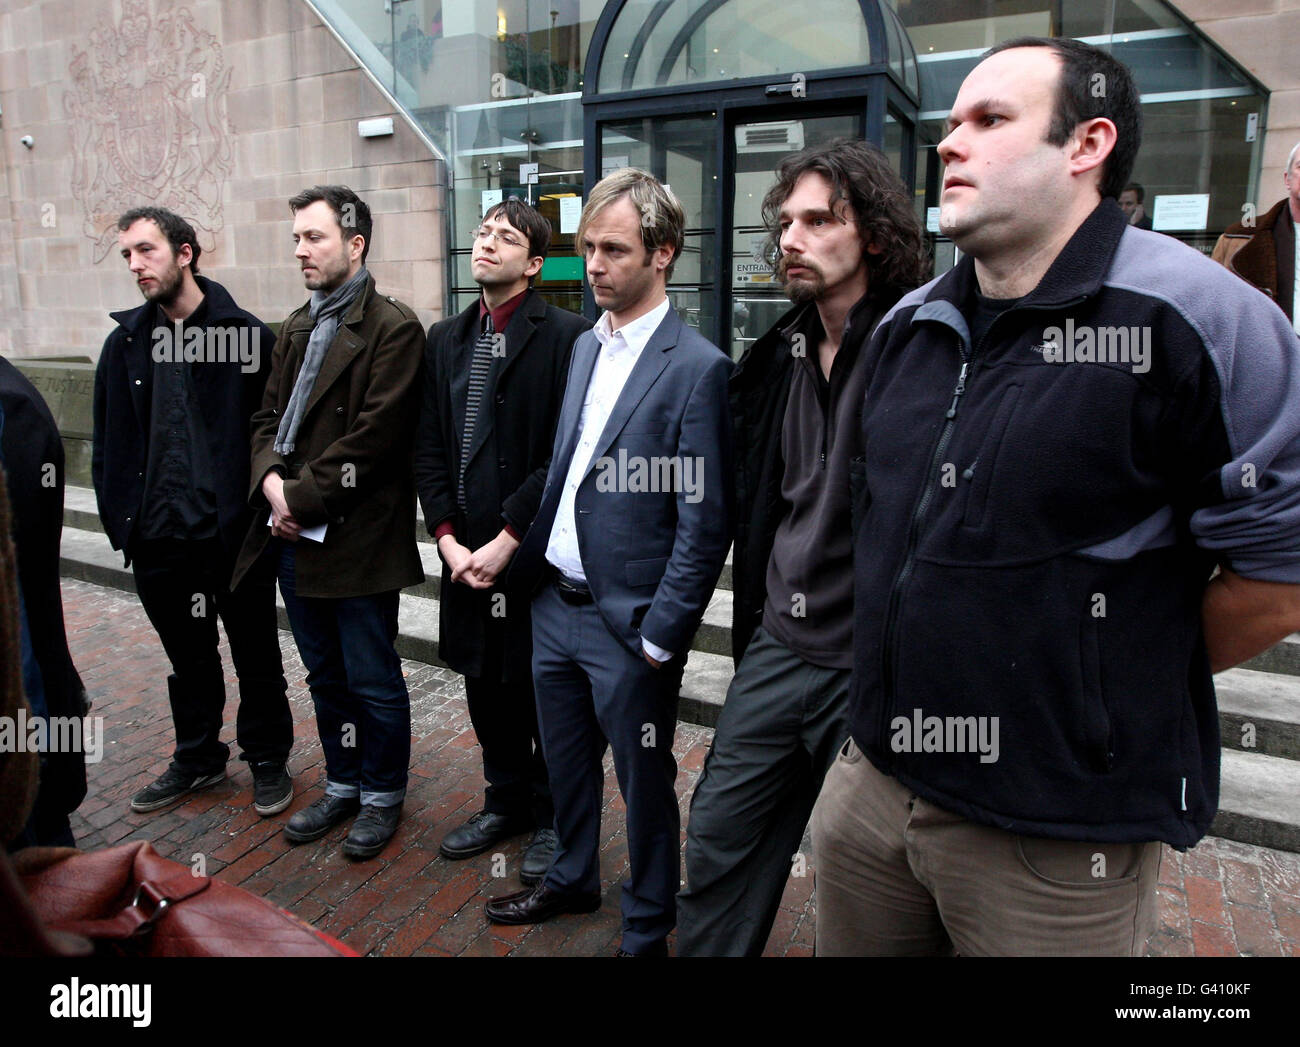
[{"left": 813, "top": 39, "right": 1300, "bottom": 955}]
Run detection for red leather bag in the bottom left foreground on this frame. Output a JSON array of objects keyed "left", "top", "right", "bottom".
[{"left": 0, "top": 840, "right": 358, "bottom": 956}]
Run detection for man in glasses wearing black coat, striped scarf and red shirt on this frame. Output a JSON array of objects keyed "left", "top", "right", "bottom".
[{"left": 415, "top": 198, "right": 592, "bottom": 883}]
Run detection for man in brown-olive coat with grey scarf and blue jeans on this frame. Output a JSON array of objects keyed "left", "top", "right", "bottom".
[{"left": 228, "top": 186, "right": 424, "bottom": 858}]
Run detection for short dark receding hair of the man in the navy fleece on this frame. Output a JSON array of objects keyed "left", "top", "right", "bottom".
[{"left": 980, "top": 36, "right": 1141, "bottom": 199}]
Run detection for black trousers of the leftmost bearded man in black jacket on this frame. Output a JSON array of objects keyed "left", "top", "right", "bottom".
[{"left": 131, "top": 538, "right": 294, "bottom": 775}]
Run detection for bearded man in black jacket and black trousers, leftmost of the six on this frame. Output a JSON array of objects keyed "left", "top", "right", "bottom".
[{"left": 92, "top": 207, "right": 294, "bottom": 815}]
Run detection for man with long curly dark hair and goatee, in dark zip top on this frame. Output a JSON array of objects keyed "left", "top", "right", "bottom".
[{"left": 677, "top": 139, "right": 930, "bottom": 956}]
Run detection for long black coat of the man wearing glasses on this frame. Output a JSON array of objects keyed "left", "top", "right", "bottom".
[{"left": 415, "top": 290, "right": 592, "bottom": 680}]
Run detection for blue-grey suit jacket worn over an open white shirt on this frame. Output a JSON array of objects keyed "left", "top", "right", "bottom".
[{"left": 511, "top": 308, "right": 733, "bottom": 657}]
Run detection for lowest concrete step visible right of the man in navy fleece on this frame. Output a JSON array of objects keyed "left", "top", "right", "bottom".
[{"left": 1210, "top": 749, "right": 1300, "bottom": 851}]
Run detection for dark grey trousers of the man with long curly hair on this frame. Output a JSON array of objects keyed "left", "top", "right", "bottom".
[{"left": 677, "top": 628, "right": 850, "bottom": 956}]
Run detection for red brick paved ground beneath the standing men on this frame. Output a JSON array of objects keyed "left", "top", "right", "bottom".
[{"left": 64, "top": 580, "right": 1300, "bottom": 956}]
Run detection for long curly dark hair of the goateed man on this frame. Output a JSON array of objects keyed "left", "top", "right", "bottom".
[{"left": 762, "top": 138, "right": 931, "bottom": 304}]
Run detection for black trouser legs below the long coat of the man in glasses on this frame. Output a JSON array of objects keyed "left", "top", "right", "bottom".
[{"left": 465, "top": 676, "right": 555, "bottom": 828}]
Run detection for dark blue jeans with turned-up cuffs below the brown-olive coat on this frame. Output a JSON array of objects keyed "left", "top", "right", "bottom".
[{"left": 278, "top": 541, "right": 411, "bottom": 808}]
